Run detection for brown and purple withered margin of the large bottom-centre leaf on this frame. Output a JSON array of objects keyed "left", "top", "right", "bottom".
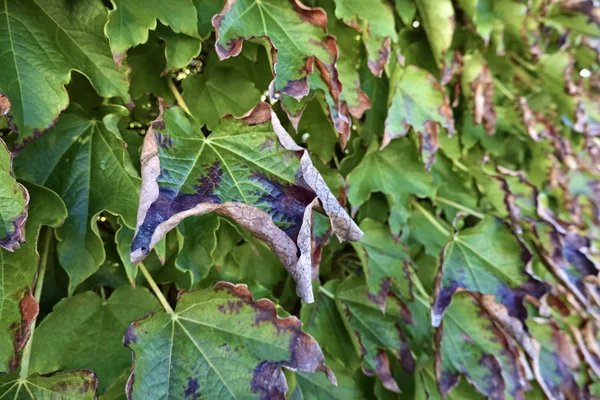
[{"left": 123, "top": 281, "right": 337, "bottom": 400}]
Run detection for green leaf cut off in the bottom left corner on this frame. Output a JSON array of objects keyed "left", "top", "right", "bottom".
[{"left": 0, "top": 370, "right": 98, "bottom": 400}]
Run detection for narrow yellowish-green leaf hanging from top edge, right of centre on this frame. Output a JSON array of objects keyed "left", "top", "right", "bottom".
[{"left": 415, "top": 0, "right": 456, "bottom": 66}]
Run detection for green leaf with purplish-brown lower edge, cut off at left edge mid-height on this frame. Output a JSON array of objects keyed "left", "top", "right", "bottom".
[{"left": 0, "top": 139, "right": 29, "bottom": 251}]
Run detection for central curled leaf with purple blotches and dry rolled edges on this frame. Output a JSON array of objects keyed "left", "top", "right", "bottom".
[{"left": 131, "top": 103, "right": 362, "bottom": 302}]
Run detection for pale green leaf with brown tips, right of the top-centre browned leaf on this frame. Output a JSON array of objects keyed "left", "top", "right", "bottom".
[{"left": 382, "top": 66, "right": 455, "bottom": 170}]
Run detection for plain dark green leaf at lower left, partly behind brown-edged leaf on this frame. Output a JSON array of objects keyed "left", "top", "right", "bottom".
[{"left": 30, "top": 287, "right": 160, "bottom": 393}]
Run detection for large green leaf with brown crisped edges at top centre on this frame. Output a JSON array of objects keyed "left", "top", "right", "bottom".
[{"left": 213, "top": 0, "right": 347, "bottom": 133}]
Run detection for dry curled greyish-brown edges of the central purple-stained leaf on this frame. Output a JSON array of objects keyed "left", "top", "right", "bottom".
[{"left": 131, "top": 102, "right": 363, "bottom": 303}]
